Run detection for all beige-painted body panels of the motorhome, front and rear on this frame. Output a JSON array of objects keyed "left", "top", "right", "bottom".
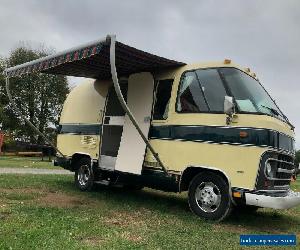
[{"left": 57, "top": 62, "right": 294, "bottom": 190}]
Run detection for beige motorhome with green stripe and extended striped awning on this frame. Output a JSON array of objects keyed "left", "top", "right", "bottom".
[{"left": 5, "top": 35, "right": 300, "bottom": 220}]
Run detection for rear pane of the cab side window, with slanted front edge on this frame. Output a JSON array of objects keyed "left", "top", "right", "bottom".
[{"left": 177, "top": 72, "right": 208, "bottom": 113}]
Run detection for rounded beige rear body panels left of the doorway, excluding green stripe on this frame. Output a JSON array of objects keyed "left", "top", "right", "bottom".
[{"left": 57, "top": 79, "right": 111, "bottom": 159}]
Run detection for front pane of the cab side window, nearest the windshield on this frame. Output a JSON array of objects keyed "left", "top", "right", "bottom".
[{"left": 196, "top": 69, "right": 226, "bottom": 112}]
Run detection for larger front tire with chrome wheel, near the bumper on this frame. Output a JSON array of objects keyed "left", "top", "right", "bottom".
[{"left": 188, "top": 172, "right": 233, "bottom": 221}]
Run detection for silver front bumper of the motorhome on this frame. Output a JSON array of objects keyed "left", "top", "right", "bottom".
[{"left": 245, "top": 190, "right": 300, "bottom": 209}]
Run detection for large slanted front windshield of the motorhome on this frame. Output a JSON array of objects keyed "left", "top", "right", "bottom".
[{"left": 219, "top": 68, "right": 286, "bottom": 120}]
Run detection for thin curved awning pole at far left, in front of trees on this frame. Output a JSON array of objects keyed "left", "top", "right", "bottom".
[{"left": 5, "top": 72, "right": 64, "bottom": 157}]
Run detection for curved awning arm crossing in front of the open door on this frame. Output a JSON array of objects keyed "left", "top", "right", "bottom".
[{"left": 109, "top": 35, "right": 168, "bottom": 174}]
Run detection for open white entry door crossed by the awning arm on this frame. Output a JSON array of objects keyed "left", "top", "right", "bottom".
[{"left": 115, "top": 72, "right": 154, "bottom": 174}]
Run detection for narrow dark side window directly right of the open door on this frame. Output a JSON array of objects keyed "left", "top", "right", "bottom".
[{"left": 153, "top": 79, "right": 173, "bottom": 120}]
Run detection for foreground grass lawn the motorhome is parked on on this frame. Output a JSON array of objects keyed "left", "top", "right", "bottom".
[{"left": 0, "top": 175, "right": 300, "bottom": 249}]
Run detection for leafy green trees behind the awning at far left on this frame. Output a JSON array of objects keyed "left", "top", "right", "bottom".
[{"left": 0, "top": 46, "right": 69, "bottom": 143}]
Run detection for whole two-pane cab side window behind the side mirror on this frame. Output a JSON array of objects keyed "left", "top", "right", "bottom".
[{"left": 177, "top": 69, "right": 227, "bottom": 113}]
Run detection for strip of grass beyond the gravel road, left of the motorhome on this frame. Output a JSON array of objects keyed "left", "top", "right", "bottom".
[{"left": 0, "top": 155, "right": 62, "bottom": 169}]
